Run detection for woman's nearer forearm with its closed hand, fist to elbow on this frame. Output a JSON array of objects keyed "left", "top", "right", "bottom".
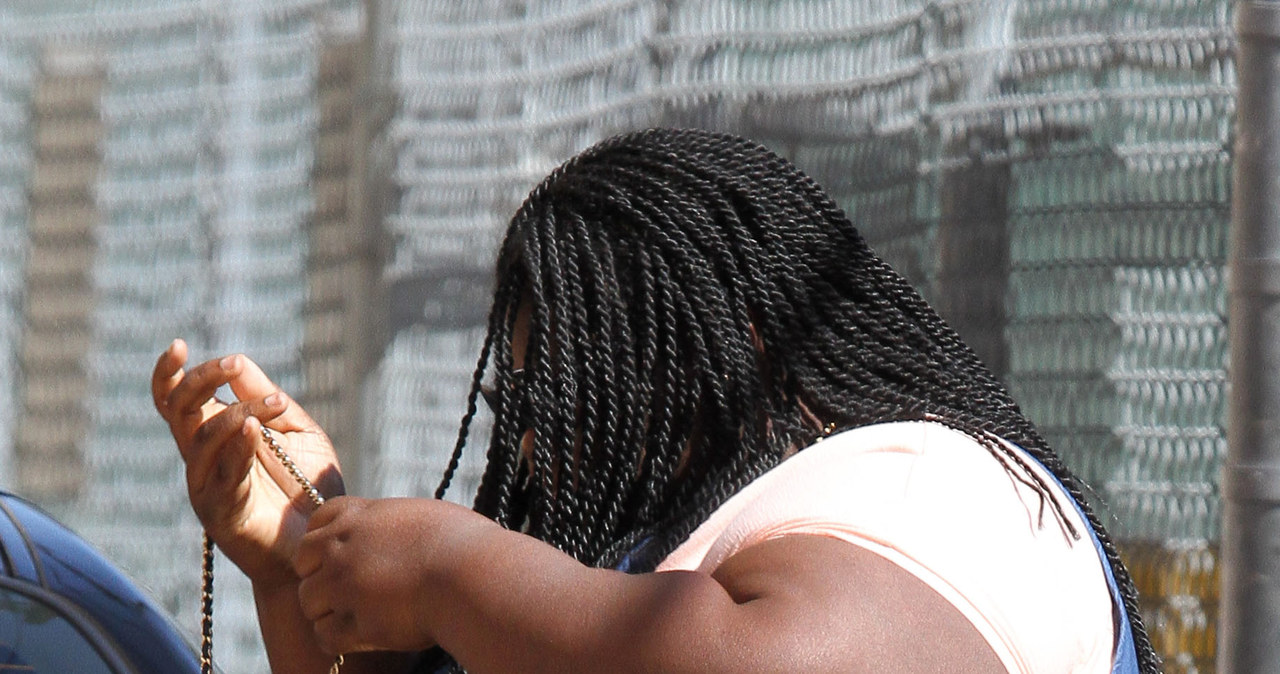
[{"left": 291, "top": 498, "right": 768, "bottom": 674}]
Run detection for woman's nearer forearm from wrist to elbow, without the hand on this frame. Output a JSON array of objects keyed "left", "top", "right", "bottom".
[{"left": 421, "top": 503, "right": 736, "bottom": 674}]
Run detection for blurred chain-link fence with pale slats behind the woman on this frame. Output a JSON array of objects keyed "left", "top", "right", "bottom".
[{"left": 0, "top": 0, "right": 1235, "bottom": 671}]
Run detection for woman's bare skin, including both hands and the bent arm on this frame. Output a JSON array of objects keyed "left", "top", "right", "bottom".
[{"left": 152, "top": 329, "right": 1004, "bottom": 674}]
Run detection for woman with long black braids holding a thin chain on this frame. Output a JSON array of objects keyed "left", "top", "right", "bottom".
[{"left": 152, "top": 129, "right": 1158, "bottom": 673}]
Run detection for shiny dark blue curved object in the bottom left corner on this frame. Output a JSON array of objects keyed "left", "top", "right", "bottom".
[{"left": 0, "top": 492, "right": 200, "bottom": 674}]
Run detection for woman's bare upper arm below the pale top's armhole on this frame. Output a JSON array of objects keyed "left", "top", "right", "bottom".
[{"left": 712, "top": 535, "right": 1005, "bottom": 673}]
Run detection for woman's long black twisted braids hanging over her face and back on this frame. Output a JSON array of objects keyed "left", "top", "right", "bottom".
[{"left": 436, "top": 129, "right": 1160, "bottom": 671}]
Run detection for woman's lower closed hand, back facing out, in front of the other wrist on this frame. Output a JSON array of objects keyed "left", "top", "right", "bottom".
[{"left": 293, "top": 496, "right": 452, "bottom": 655}]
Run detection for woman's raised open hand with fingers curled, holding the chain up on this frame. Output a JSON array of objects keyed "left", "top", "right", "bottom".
[{"left": 151, "top": 339, "right": 343, "bottom": 587}]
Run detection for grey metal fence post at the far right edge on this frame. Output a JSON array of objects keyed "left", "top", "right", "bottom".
[{"left": 1217, "top": 0, "right": 1280, "bottom": 674}]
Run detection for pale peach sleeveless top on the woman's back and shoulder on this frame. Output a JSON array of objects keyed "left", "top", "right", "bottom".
[{"left": 657, "top": 422, "right": 1115, "bottom": 674}]
